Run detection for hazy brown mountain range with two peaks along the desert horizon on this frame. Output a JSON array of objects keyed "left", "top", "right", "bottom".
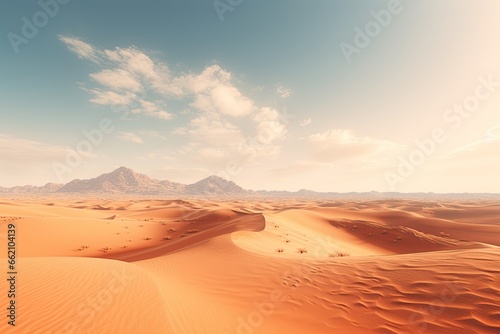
[{"left": 0, "top": 167, "right": 500, "bottom": 199}]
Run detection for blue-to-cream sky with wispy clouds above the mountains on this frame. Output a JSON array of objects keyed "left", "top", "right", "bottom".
[{"left": 0, "top": 0, "right": 500, "bottom": 193}]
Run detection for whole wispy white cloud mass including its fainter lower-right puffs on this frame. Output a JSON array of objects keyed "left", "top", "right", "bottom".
[{"left": 60, "top": 37, "right": 291, "bottom": 170}]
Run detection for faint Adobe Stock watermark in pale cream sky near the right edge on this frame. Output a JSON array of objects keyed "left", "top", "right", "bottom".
[{"left": 384, "top": 74, "right": 500, "bottom": 191}]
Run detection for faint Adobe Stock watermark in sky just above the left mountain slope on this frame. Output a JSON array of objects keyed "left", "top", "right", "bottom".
[{"left": 52, "top": 118, "right": 116, "bottom": 183}]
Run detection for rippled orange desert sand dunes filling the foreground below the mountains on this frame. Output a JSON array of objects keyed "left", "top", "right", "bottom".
[{"left": 0, "top": 196, "right": 500, "bottom": 334}]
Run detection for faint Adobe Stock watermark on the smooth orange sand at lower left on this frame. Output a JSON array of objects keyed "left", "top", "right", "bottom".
[{"left": 54, "top": 268, "right": 135, "bottom": 334}]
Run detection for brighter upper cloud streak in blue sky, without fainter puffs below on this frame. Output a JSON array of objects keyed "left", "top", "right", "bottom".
[{"left": 60, "top": 36, "right": 254, "bottom": 120}]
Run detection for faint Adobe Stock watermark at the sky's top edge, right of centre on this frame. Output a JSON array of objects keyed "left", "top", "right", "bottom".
[{"left": 339, "top": 0, "right": 411, "bottom": 64}]
